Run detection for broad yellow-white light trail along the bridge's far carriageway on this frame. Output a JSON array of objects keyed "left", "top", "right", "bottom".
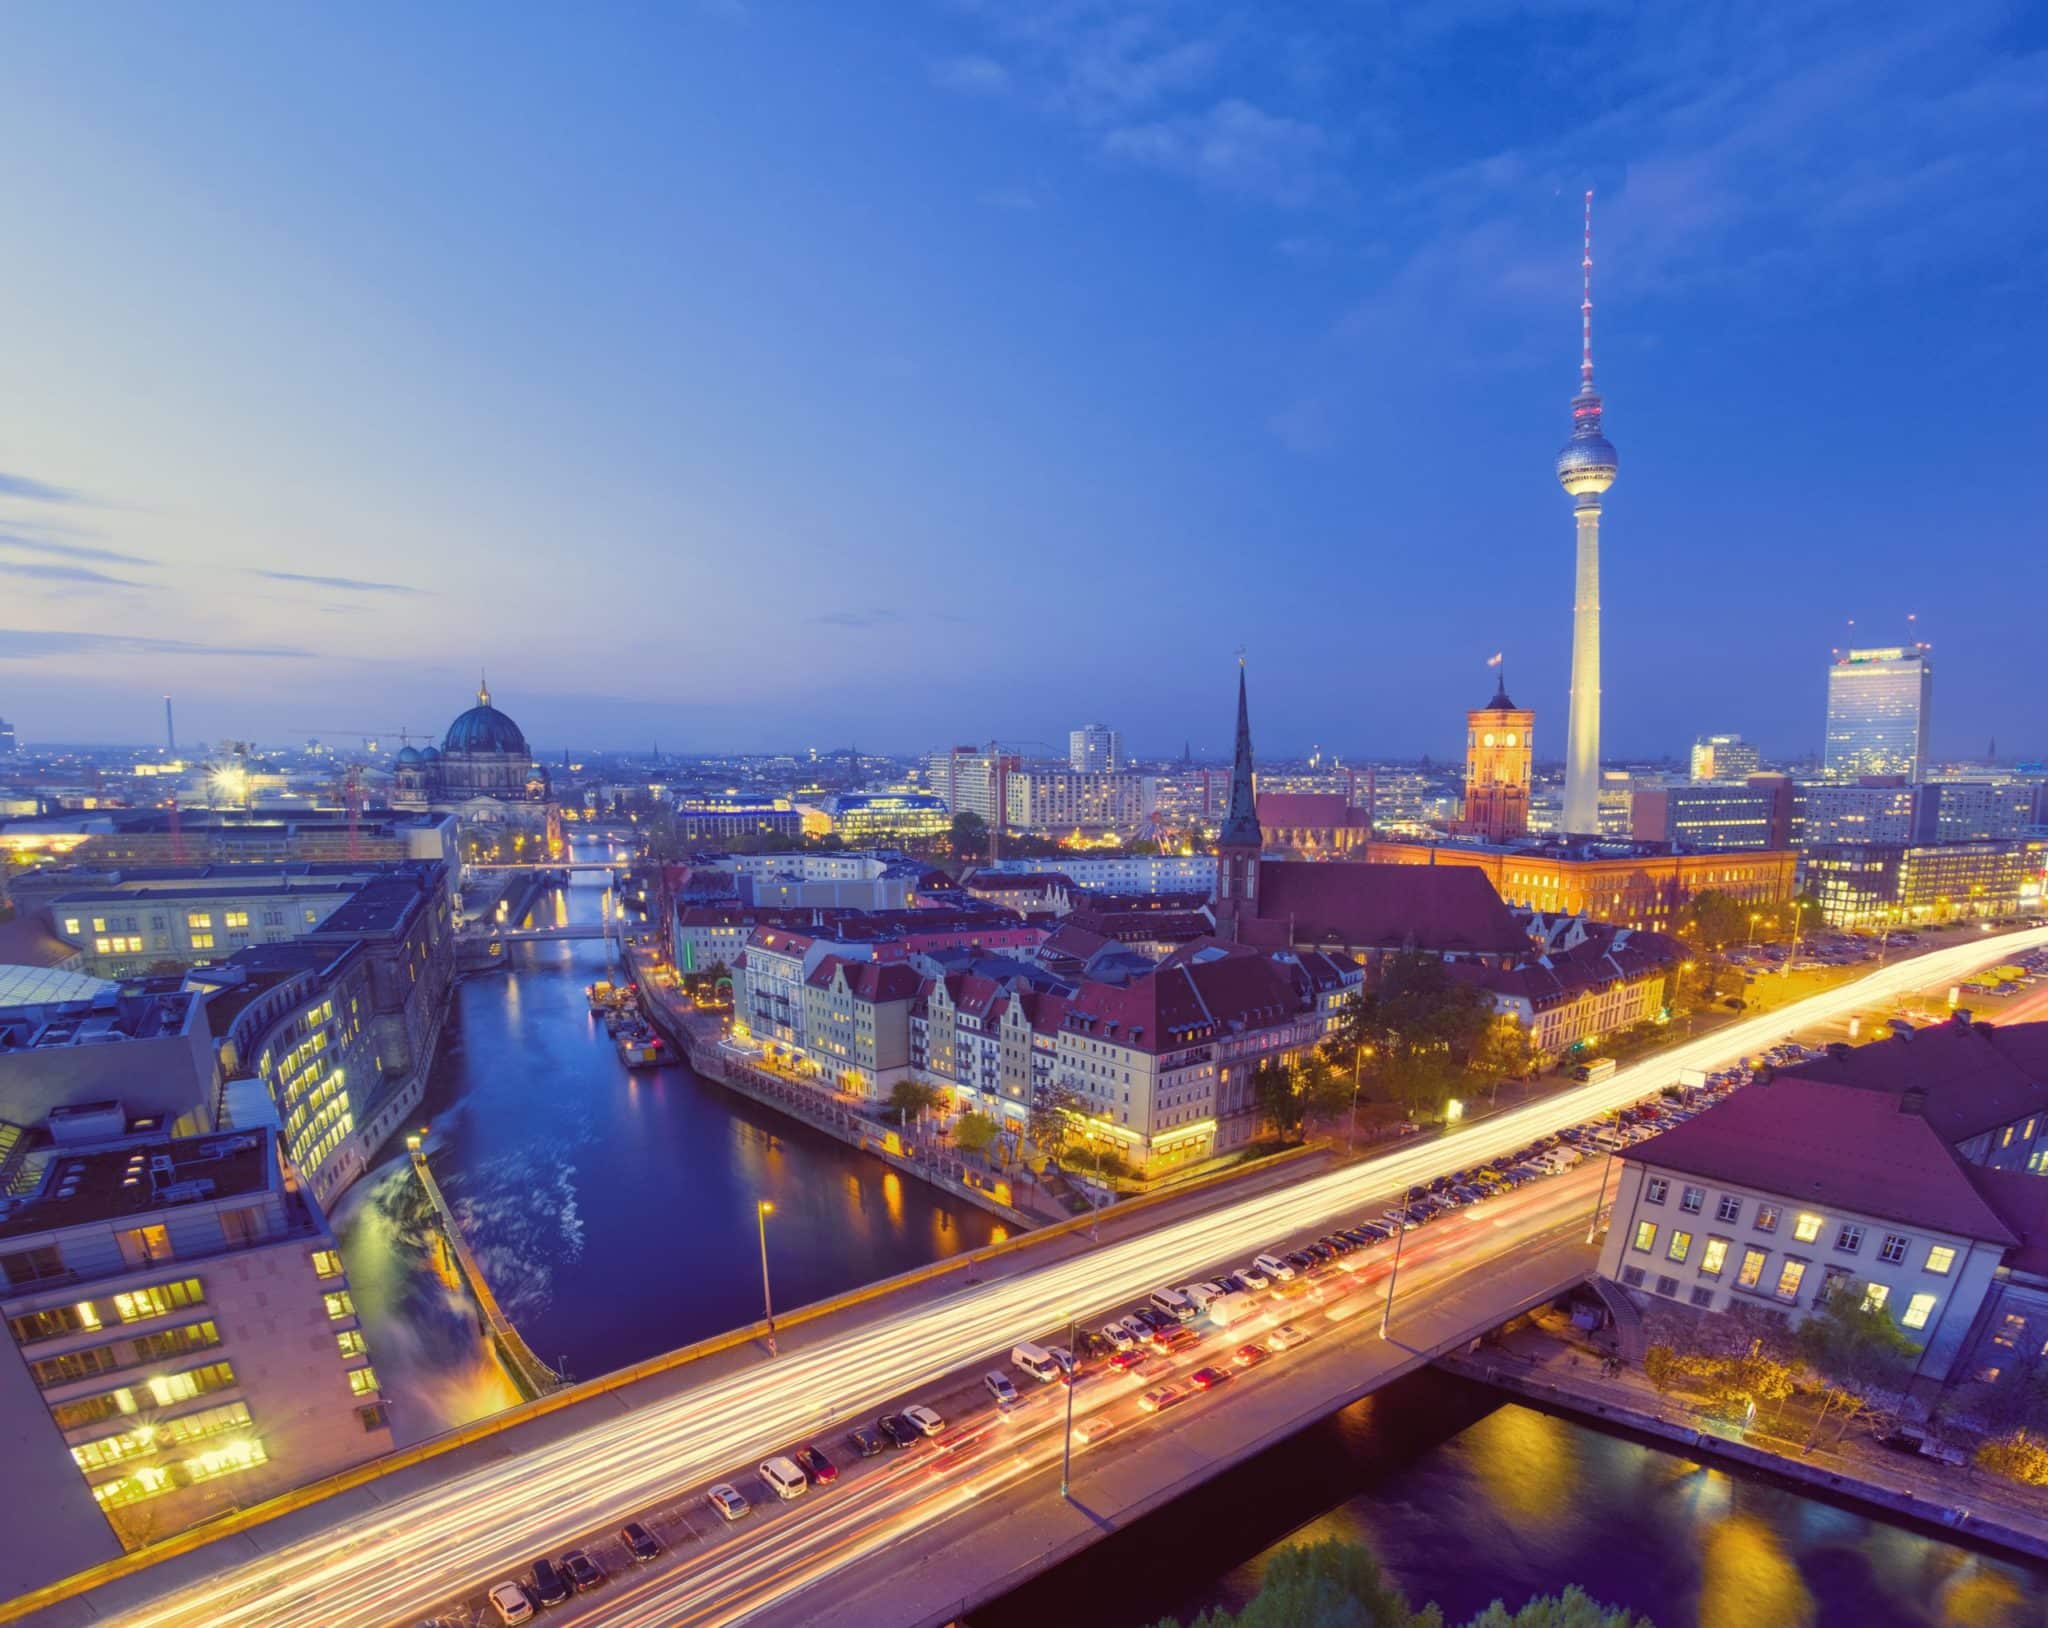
[{"left": 99, "top": 928, "right": 2048, "bottom": 1628}]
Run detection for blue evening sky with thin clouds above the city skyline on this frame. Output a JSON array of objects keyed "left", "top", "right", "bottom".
[{"left": 0, "top": 0, "right": 2048, "bottom": 756}]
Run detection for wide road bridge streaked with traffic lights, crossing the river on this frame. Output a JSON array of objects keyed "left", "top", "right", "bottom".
[{"left": 19, "top": 930, "right": 2048, "bottom": 1628}]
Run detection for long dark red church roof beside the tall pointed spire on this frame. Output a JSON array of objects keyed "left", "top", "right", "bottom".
[{"left": 1245, "top": 860, "right": 1530, "bottom": 954}]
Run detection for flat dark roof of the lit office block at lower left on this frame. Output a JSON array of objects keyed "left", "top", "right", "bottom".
[{"left": 0, "top": 1128, "right": 276, "bottom": 1239}]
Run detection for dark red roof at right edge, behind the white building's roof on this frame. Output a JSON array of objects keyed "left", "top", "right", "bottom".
[{"left": 1788, "top": 1022, "right": 2048, "bottom": 1143}]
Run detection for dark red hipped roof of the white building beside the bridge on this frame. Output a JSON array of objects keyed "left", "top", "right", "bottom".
[{"left": 1622, "top": 1075, "right": 2019, "bottom": 1253}]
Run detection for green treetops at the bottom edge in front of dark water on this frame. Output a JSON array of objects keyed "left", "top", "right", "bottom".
[{"left": 1157, "top": 1538, "right": 1655, "bottom": 1628}]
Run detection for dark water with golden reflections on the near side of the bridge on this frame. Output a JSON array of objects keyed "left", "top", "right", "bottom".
[{"left": 973, "top": 1372, "right": 2048, "bottom": 1628}]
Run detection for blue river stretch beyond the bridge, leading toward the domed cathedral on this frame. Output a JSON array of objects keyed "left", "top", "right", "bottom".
[{"left": 336, "top": 850, "right": 1004, "bottom": 1442}]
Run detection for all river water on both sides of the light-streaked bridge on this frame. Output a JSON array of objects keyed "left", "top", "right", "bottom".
[{"left": 336, "top": 852, "right": 2048, "bottom": 1628}]
